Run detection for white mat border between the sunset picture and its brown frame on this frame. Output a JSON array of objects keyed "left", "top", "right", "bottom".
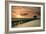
[{"left": 9, "top": 3, "right": 43, "bottom": 31}]
